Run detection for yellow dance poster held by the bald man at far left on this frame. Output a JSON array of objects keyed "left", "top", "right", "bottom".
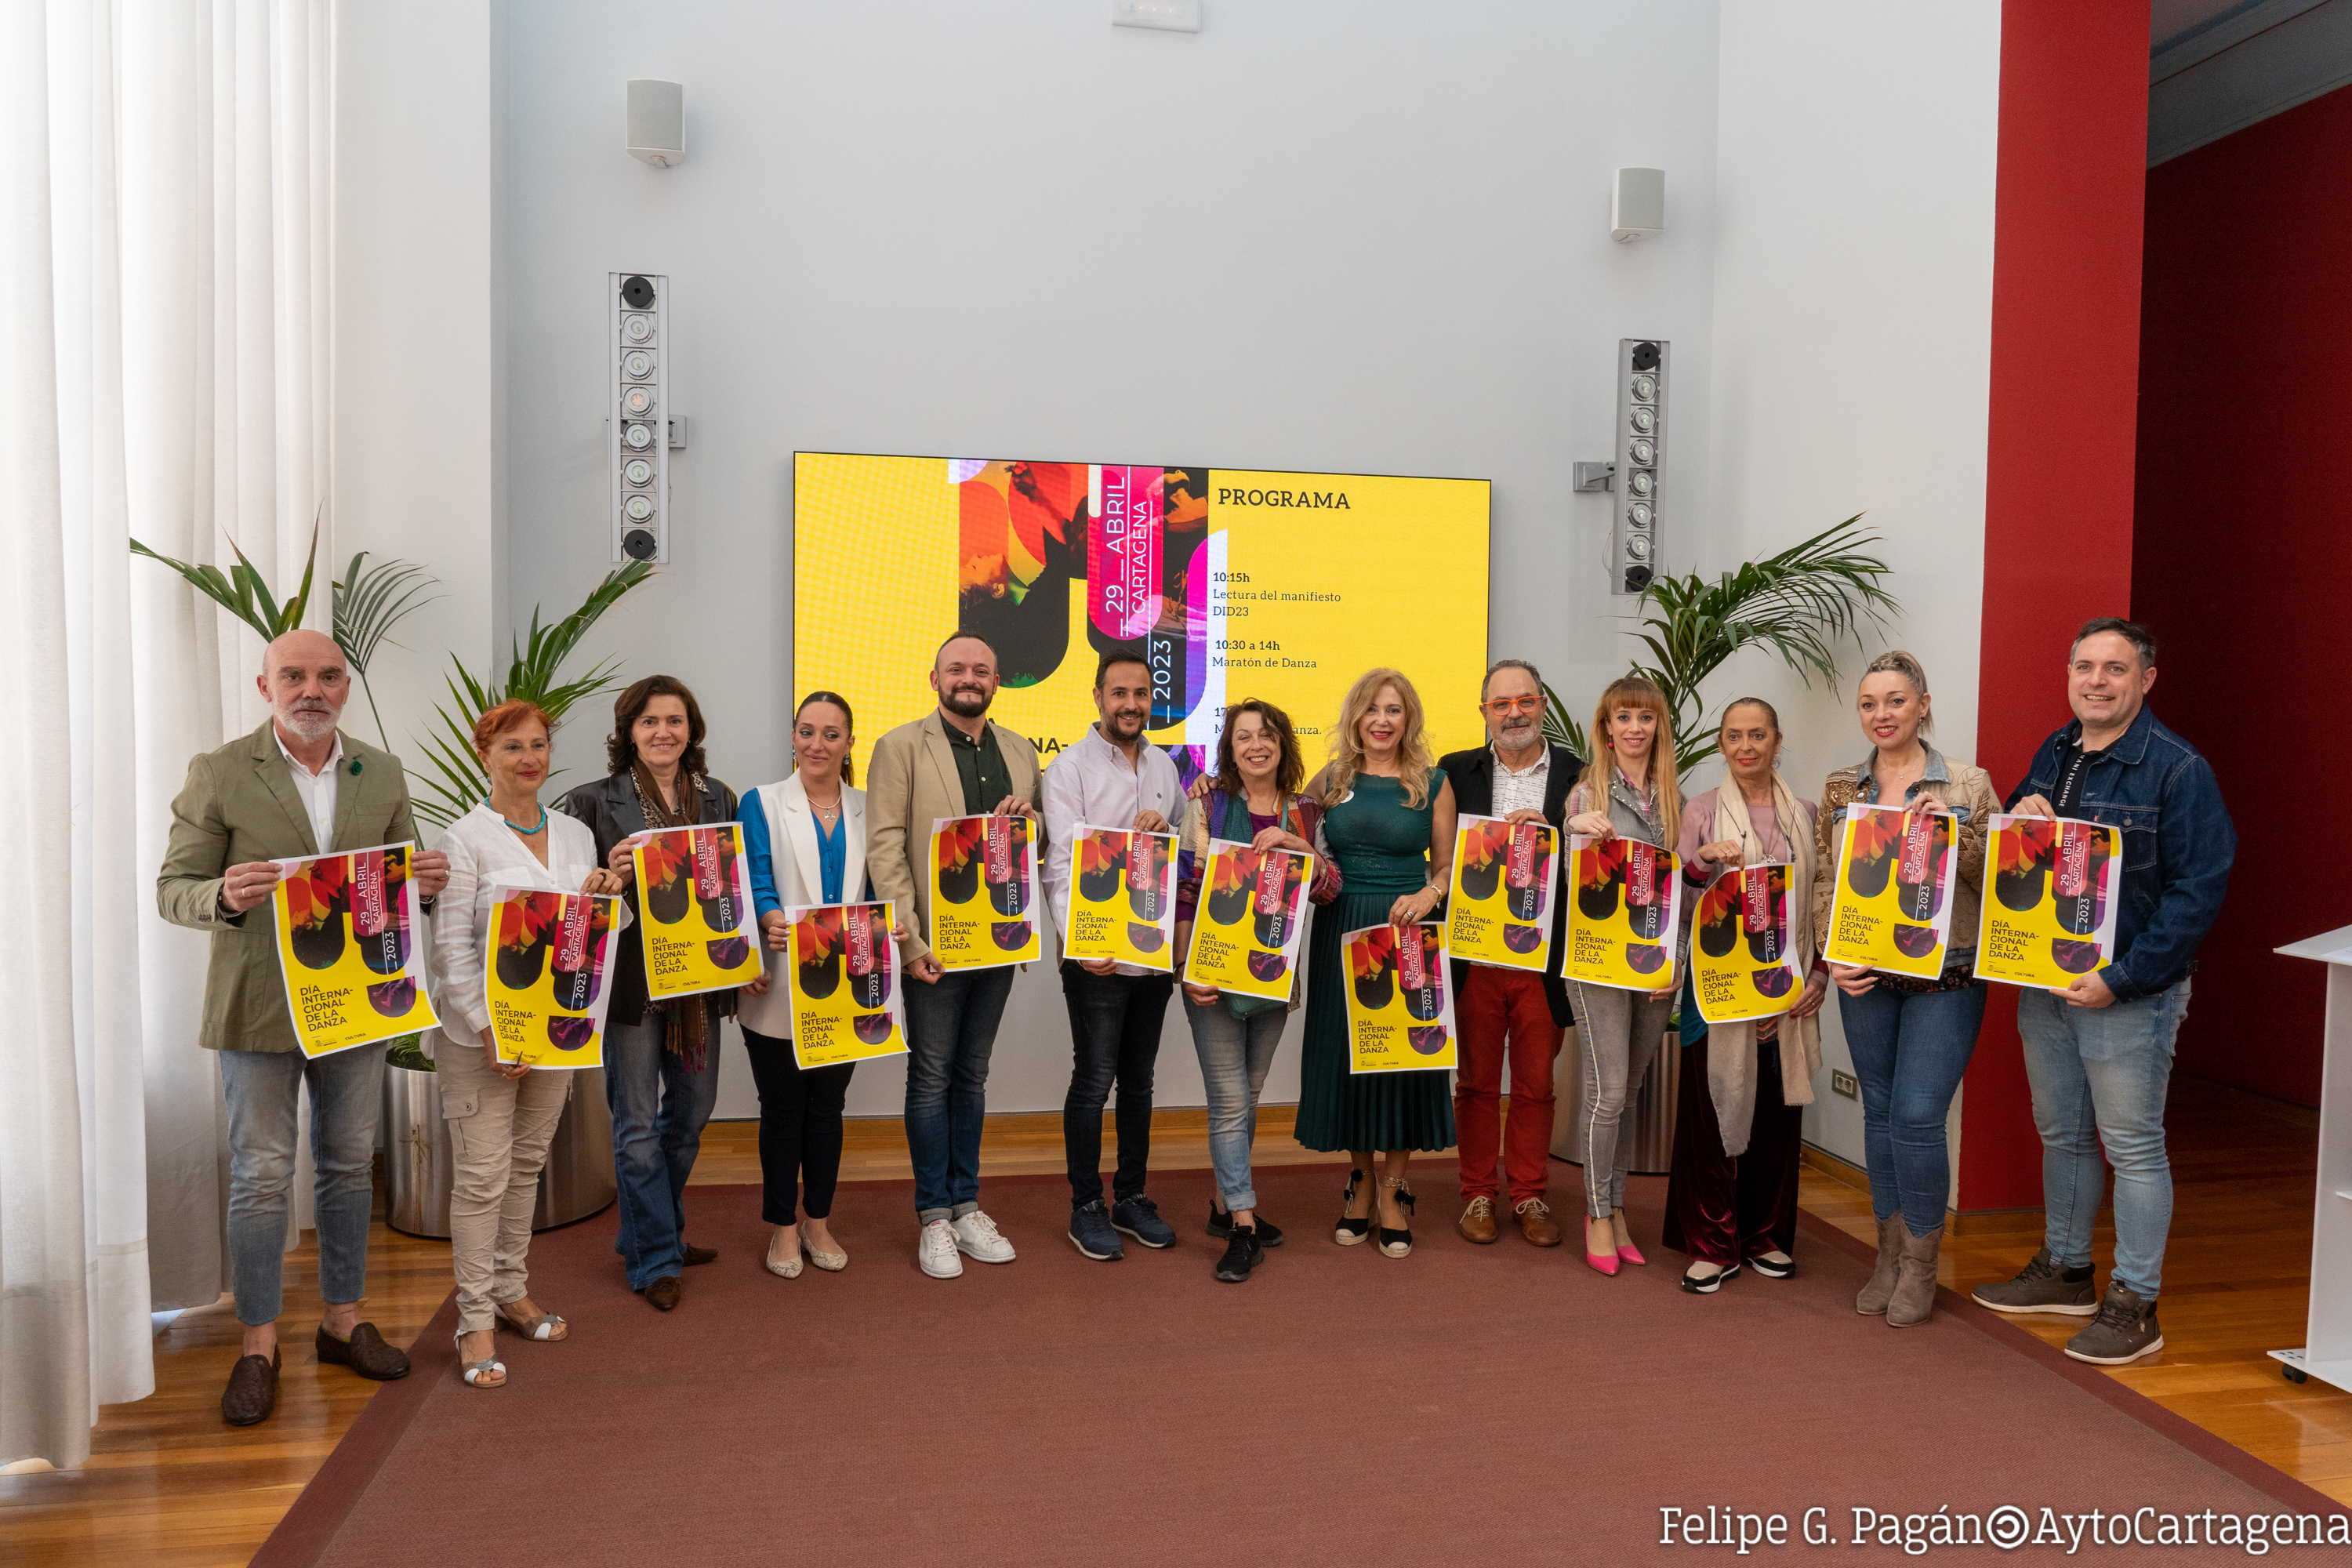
[{"left": 270, "top": 844, "right": 440, "bottom": 1055}]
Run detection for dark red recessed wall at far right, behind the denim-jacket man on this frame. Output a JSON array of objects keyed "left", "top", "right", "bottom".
[{"left": 2131, "top": 76, "right": 2352, "bottom": 1105}]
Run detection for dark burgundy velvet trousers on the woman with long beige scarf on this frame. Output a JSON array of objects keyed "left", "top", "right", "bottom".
[{"left": 1665, "top": 1032, "right": 1804, "bottom": 1269}]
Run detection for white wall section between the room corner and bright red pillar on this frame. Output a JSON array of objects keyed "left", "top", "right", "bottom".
[{"left": 1696, "top": 0, "right": 2002, "bottom": 1173}]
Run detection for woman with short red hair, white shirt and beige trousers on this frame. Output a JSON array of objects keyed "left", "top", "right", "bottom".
[{"left": 426, "top": 701, "right": 626, "bottom": 1389}]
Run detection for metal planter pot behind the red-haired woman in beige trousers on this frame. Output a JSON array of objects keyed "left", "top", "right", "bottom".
[{"left": 383, "top": 1067, "right": 614, "bottom": 1241}]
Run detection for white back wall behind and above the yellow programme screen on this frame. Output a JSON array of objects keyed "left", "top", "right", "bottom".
[{"left": 492, "top": 0, "right": 1717, "bottom": 1114}]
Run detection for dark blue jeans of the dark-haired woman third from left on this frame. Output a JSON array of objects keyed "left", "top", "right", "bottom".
[{"left": 604, "top": 1020, "right": 720, "bottom": 1290}]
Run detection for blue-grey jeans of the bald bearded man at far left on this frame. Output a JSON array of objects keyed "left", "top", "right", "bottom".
[{"left": 219, "top": 1046, "right": 383, "bottom": 1328}]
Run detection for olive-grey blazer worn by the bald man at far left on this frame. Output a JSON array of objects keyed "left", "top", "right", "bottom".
[{"left": 155, "top": 724, "right": 416, "bottom": 1051}]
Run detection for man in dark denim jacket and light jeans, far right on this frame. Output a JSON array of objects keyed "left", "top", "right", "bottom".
[{"left": 1976, "top": 619, "right": 2237, "bottom": 1366}]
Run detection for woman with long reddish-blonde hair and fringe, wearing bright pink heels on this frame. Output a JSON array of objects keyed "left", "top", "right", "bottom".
[{"left": 1569, "top": 675, "right": 1682, "bottom": 1274}]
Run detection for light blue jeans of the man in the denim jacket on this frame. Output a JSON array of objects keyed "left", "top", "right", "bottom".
[{"left": 2018, "top": 980, "right": 2190, "bottom": 1300}]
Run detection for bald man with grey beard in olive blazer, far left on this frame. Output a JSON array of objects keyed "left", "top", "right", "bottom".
[{"left": 155, "top": 633, "right": 449, "bottom": 1427}]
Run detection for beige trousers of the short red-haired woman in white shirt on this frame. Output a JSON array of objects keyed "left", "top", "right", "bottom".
[{"left": 433, "top": 1041, "right": 574, "bottom": 1333}]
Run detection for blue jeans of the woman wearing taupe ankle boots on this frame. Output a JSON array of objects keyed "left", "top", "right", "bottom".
[{"left": 1837, "top": 975, "right": 1985, "bottom": 1236}]
